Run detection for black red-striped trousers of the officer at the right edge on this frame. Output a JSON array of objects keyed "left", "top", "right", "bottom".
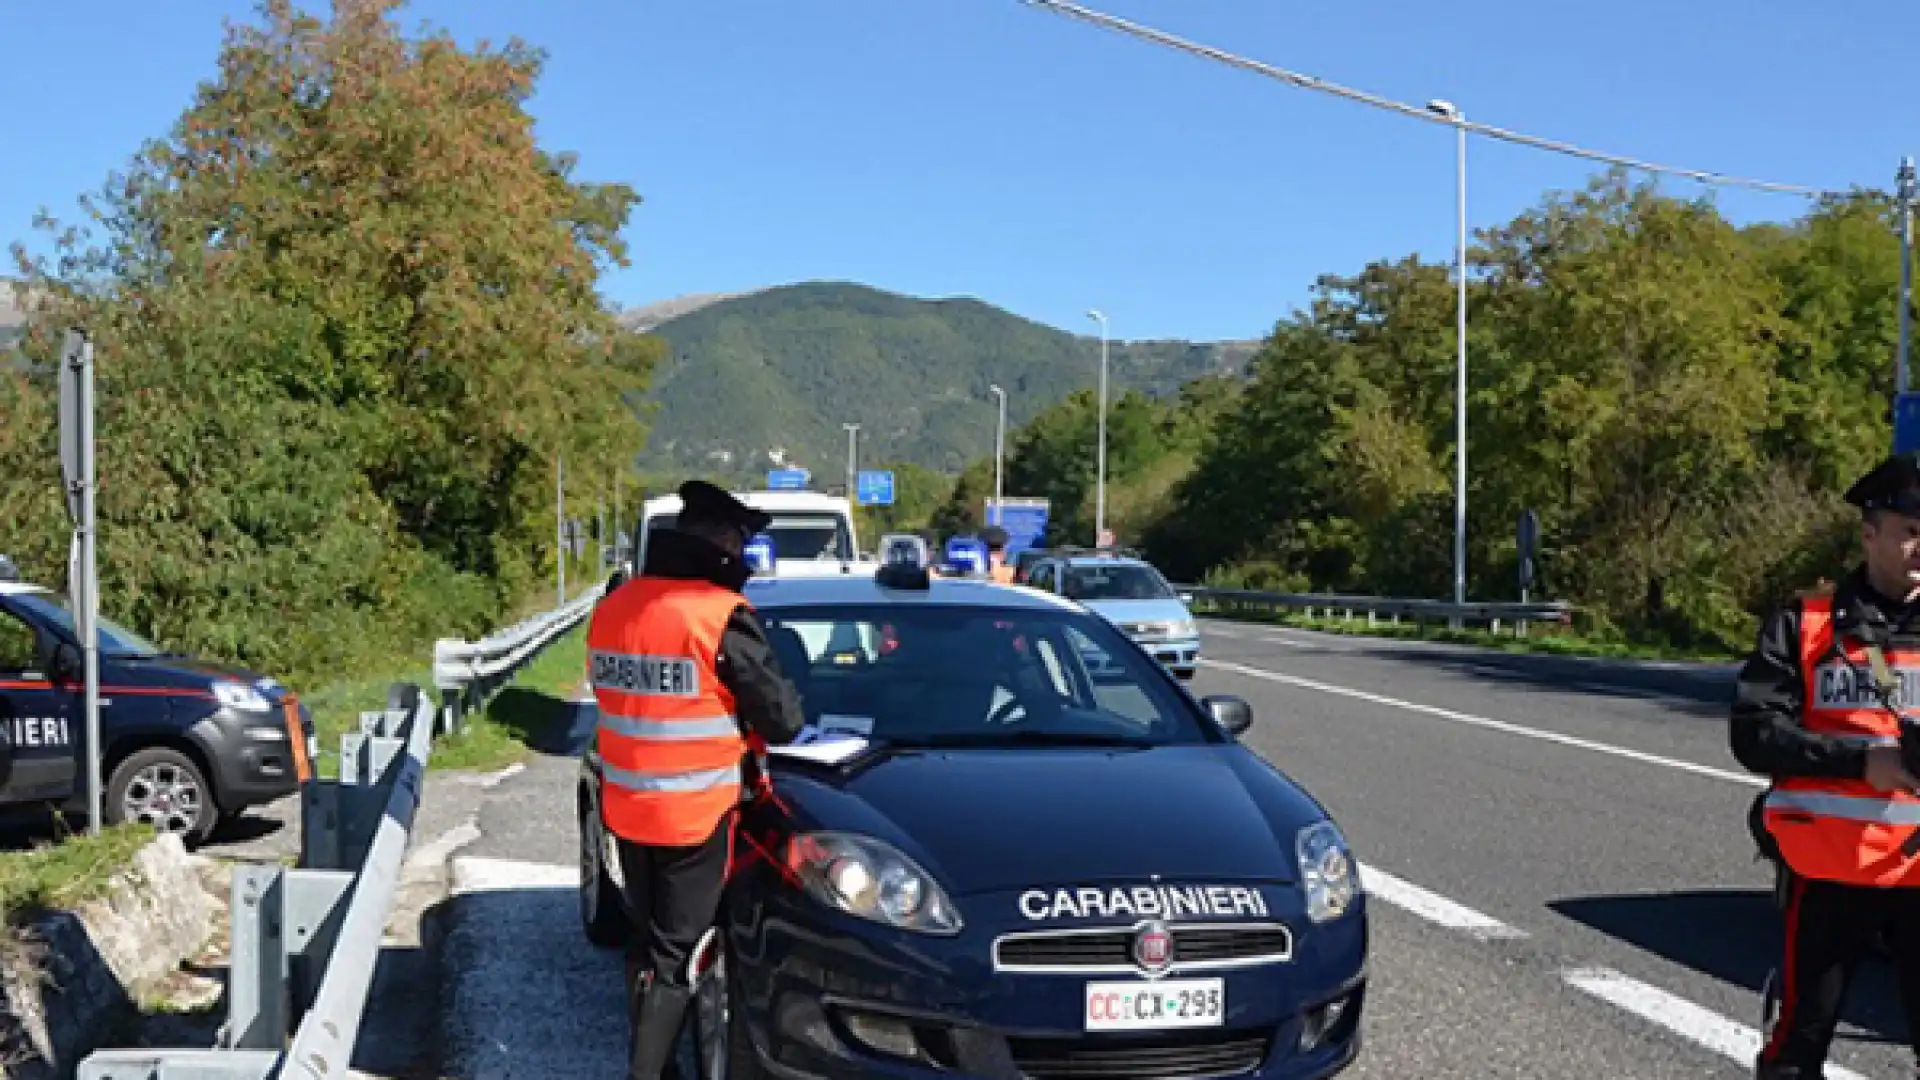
[{"left": 1761, "top": 874, "right": 1920, "bottom": 1076}]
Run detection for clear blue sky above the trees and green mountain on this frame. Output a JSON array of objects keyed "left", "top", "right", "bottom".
[{"left": 0, "top": 0, "right": 1920, "bottom": 338}]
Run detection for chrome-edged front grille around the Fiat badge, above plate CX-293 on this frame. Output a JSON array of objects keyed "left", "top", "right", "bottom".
[{"left": 993, "top": 922, "right": 1294, "bottom": 974}]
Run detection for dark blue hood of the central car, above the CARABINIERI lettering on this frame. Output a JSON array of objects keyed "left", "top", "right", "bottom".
[{"left": 776, "top": 744, "right": 1327, "bottom": 896}]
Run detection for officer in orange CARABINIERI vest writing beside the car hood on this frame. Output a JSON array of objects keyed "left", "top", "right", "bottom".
[{"left": 588, "top": 480, "right": 806, "bottom": 1080}]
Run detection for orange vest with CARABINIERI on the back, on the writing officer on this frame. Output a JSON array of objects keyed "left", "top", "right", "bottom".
[{"left": 588, "top": 577, "right": 747, "bottom": 847}]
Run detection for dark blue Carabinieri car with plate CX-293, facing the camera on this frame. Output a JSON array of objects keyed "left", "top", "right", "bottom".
[{"left": 578, "top": 545, "right": 1369, "bottom": 1080}]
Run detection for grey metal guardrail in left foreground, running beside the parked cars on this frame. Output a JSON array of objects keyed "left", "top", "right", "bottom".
[{"left": 75, "top": 586, "right": 605, "bottom": 1080}]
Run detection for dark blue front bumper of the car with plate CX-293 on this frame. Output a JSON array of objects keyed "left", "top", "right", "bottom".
[{"left": 730, "top": 892, "right": 1367, "bottom": 1080}]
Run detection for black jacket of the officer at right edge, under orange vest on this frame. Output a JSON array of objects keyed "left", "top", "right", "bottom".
[{"left": 1728, "top": 557, "right": 1920, "bottom": 780}]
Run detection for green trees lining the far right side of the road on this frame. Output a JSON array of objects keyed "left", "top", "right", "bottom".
[{"left": 929, "top": 173, "right": 1899, "bottom": 657}]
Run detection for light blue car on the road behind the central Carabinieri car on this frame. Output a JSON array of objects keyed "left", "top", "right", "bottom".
[{"left": 1025, "top": 548, "right": 1200, "bottom": 678}]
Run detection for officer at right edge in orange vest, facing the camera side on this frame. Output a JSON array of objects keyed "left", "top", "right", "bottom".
[{"left": 1730, "top": 454, "right": 1920, "bottom": 1080}]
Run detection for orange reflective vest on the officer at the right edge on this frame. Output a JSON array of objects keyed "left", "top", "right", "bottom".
[{"left": 1763, "top": 596, "right": 1920, "bottom": 886}]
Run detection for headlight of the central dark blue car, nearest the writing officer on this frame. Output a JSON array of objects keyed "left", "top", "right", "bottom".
[{"left": 787, "top": 832, "right": 960, "bottom": 934}]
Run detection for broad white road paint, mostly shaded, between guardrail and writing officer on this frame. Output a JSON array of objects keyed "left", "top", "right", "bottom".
[{"left": 442, "top": 855, "right": 626, "bottom": 1080}]
